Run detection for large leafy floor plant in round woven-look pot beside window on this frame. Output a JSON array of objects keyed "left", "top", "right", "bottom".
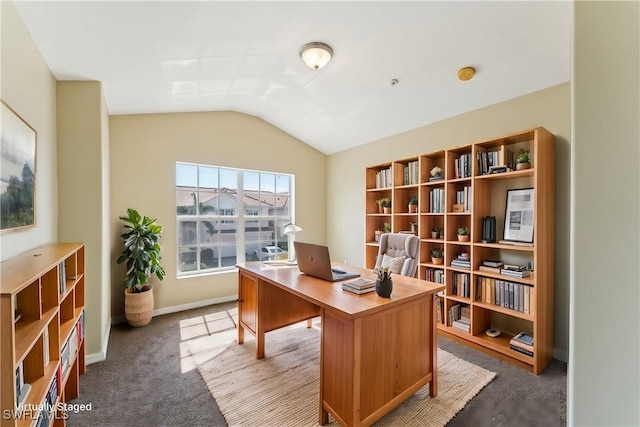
[{"left": 117, "top": 209, "right": 165, "bottom": 327}]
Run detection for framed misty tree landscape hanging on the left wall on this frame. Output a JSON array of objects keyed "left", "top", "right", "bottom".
[{"left": 0, "top": 100, "right": 38, "bottom": 232}]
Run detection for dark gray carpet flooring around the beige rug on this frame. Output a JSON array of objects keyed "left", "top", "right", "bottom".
[{"left": 67, "top": 303, "right": 567, "bottom": 427}]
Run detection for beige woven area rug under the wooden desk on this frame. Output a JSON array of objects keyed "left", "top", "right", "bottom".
[{"left": 196, "top": 324, "right": 496, "bottom": 427}]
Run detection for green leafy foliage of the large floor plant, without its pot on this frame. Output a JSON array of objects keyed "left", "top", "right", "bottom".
[{"left": 117, "top": 209, "right": 165, "bottom": 292}]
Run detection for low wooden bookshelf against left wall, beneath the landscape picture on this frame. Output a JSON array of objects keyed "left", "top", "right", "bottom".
[{"left": 0, "top": 243, "right": 86, "bottom": 427}]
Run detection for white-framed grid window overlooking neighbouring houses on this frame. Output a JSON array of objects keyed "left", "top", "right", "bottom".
[{"left": 176, "top": 162, "right": 294, "bottom": 276}]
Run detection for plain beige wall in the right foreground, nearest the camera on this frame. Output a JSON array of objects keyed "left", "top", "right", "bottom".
[{"left": 567, "top": 1, "right": 640, "bottom": 426}]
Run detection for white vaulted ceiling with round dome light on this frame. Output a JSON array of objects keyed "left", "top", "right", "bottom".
[{"left": 16, "top": 1, "right": 571, "bottom": 154}]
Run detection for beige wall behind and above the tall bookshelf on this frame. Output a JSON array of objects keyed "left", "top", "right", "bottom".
[{"left": 327, "top": 83, "right": 571, "bottom": 361}]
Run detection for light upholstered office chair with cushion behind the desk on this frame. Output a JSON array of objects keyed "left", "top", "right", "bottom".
[{"left": 375, "top": 233, "right": 420, "bottom": 277}]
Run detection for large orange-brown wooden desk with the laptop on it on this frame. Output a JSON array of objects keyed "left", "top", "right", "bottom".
[{"left": 238, "top": 262, "right": 444, "bottom": 426}]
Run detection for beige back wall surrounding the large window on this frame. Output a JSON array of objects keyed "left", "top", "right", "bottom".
[{"left": 110, "top": 112, "right": 326, "bottom": 320}]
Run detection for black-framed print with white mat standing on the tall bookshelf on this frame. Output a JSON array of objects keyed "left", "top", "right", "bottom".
[{"left": 503, "top": 188, "right": 535, "bottom": 244}]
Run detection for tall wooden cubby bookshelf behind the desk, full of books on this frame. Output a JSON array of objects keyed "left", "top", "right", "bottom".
[{"left": 365, "top": 127, "right": 555, "bottom": 374}]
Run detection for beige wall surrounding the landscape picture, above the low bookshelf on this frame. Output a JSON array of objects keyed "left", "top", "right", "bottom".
[{"left": 0, "top": 1, "right": 58, "bottom": 260}]
